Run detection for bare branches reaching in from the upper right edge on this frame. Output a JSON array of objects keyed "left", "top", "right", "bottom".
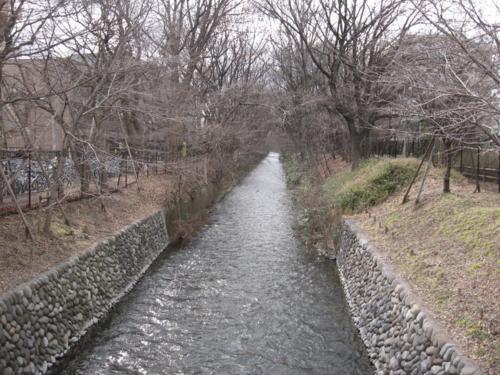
[{"left": 418, "top": 0, "right": 500, "bottom": 149}]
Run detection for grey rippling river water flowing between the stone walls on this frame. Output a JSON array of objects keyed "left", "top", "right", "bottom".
[{"left": 51, "top": 153, "right": 373, "bottom": 375}]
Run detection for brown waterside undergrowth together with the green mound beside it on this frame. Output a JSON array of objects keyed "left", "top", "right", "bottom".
[{"left": 280, "top": 153, "right": 418, "bottom": 255}]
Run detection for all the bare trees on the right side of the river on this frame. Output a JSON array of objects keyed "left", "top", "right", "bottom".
[{"left": 258, "top": 0, "right": 500, "bottom": 184}]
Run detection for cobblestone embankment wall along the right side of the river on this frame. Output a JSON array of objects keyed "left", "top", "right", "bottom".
[{"left": 337, "top": 219, "right": 484, "bottom": 375}]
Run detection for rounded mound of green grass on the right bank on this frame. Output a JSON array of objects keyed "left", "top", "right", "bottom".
[{"left": 323, "top": 158, "right": 418, "bottom": 213}]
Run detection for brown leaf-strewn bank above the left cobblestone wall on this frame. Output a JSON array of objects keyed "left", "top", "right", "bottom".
[{"left": 0, "top": 156, "right": 266, "bottom": 295}]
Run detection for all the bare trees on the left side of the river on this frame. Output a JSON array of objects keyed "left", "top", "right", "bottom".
[{"left": 0, "top": 0, "right": 269, "bottom": 236}]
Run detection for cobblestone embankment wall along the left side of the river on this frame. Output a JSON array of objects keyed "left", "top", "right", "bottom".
[{"left": 0, "top": 210, "right": 169, "bottom": 375}]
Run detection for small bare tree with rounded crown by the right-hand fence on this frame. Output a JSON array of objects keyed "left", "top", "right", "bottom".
[{"left": 394, "top": 33, "right": 495, "bottom": 192}]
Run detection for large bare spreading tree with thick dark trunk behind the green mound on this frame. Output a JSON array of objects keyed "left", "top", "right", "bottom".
[{"left": 259, "top": 0, "right": 415, "bottom": 168}]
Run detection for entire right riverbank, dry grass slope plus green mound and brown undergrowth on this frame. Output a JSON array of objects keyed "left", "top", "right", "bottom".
[{"left": 288, "top": 153, "right": 500, "bottom": 375}]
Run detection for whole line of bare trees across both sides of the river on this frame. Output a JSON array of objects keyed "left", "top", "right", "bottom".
[{"left": 0, "top": 0, "right": 500, "bottom": 236}]
